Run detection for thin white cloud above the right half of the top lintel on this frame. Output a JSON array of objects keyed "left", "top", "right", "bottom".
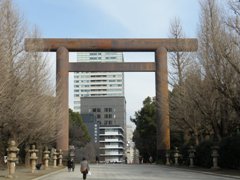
[{"left": 83, "top": 0, "right": 196, "bottom": 37}]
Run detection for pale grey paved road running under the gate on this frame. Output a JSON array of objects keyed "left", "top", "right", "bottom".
[{"left": 34, "top": 164, "right": 240, "bottom": 180}]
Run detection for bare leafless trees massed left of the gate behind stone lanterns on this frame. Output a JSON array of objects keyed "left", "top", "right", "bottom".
[{"left": 0, "top": 0, "right": 57, "bottom": 164}]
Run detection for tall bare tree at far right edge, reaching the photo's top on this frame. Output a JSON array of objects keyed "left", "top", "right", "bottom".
[{"left": 199, "top": 0, "right": 240, "bottom": 140}]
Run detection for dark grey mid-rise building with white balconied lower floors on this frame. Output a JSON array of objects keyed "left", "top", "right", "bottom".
[{"left": 81, "top": 96, "right": 126, "bottom": 163}]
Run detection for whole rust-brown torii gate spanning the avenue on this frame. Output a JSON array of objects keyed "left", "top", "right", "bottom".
[{"left": 25, "top": 38, "right": 198, "bottom": 159}]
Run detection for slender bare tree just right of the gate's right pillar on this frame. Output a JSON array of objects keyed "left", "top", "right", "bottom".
[{"left": 169, "top": 18, "right": 206, "bottom": 144}]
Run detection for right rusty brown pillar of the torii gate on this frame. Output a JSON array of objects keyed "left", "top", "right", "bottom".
[{"left": 155, "top": 47, "right": 170, "bottom": 160}]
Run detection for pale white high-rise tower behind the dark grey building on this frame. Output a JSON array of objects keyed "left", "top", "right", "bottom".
[{"left": 73, "top": 52, "right": 124, "bottom": 113}]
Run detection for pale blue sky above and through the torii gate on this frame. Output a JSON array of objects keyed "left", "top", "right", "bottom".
[{"left": 13, "top": 0, "right": 200, "bottom": 126}]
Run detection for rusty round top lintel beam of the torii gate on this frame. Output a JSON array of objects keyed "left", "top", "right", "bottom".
[{"left": 25, "top": 38, "right": 198, "bottom": 52}]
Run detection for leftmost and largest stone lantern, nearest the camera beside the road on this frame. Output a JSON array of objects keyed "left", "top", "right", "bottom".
[{"left": 7, "top": 140, "right": 19, "bottom": 178}]
